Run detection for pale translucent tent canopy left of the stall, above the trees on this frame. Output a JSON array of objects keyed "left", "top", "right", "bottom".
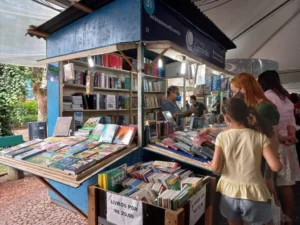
[{"left": 0, "top": 0, "right": 59, "bottom": 66}]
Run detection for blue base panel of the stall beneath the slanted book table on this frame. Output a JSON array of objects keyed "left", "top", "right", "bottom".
[{"left": 48, "top": 149, "right": 142, "bottom": 213}]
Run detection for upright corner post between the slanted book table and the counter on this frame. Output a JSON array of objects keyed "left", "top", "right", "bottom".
[{"left": 137, "top": 42, "right": 144, "bottom": 146}]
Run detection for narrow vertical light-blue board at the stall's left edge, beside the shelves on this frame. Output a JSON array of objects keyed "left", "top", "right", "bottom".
[{"left": 47, "top": 63, "right": 61, "bottom": 137}]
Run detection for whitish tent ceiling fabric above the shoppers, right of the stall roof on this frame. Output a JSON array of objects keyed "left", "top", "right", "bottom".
[{"left": 194, "top": 0, "right": 300, "bottom": 70}]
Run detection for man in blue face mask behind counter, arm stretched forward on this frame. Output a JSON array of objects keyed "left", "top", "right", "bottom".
[{"left": 161, "top": 86, "right": 198, "bottom": 119}]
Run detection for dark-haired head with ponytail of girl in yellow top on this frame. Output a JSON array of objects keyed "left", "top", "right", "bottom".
[{"left": 222, "top": 98, "right": 273, "bottom": 137}]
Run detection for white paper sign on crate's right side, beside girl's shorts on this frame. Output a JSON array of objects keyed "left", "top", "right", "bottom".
[{"left": 190, "top": 185, "right": 206, "bottom": 225}]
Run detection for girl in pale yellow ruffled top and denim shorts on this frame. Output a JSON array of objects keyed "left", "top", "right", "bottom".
[{"left": 210, "top": 98, "right": 282, "bottom": 225}]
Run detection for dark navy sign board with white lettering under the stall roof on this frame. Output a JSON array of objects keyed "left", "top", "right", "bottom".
[{"left": 142, "top": 0, "right": 226, "bottom": 68}]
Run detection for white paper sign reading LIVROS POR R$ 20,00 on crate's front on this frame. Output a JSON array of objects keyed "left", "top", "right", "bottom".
[{"left": 106, "top": 192, "right": 143, "bottom": 225}]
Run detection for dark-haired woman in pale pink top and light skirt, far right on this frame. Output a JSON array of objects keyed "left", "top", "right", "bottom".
[{"left": 258, "top": 70, "right": 300, "bottom": 224}]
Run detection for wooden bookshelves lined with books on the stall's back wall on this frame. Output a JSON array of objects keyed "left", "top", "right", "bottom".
[{"left": 60, "top": 56, "right": 166, "bottom": 124}]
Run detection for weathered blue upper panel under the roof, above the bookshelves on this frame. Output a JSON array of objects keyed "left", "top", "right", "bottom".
[{"left": 47, "top": 0, "right": 141, "bottom": 58}]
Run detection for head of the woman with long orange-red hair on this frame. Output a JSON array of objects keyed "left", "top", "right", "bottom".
[{"left": 231, "top": 73, "right": 270, "bottom": 107}]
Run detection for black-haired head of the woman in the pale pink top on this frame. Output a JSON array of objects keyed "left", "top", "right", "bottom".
[{"left": 258, "top": 70, "right": 289, "bottom": 101}]
